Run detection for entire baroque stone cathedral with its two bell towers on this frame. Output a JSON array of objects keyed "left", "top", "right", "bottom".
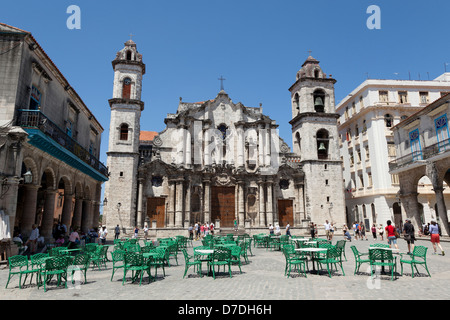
[{"left": 104, "top": 40, "right": 345, "bottom": 236}]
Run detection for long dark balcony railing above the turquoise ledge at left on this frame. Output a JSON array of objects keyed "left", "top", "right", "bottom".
[{"left": 17, "top": 110, "right": 108, "bottom": 177}]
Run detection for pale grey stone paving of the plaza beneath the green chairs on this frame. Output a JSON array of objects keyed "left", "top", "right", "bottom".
[{"left": 0, "top": 237, "right": 450, "bottom": 301}]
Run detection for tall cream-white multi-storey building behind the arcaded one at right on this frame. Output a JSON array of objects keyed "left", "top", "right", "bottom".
[{"left": 336, "top": 74, "right": 450, "bottom": 228}]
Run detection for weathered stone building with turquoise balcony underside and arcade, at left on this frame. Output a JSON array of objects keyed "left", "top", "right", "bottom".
[{"left": 0, "top": 23, "right": 107, "bottom": 239}]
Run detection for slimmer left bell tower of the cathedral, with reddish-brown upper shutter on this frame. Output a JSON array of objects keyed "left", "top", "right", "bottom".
[{"left": 103, "top": 40, "right": 145, "bottom": 232}]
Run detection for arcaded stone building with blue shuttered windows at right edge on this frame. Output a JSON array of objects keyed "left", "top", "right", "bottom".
[{"left": 389, "top": 93, "right": 450, "bottom": 235}]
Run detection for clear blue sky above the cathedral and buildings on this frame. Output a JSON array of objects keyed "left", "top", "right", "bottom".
[{"left": 0, "top": 0, "right": 450, "bottom": 163}]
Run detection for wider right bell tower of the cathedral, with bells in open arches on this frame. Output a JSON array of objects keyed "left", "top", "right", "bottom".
[{"left": 289, "top": 56, "right": 345, "bottom": 227}]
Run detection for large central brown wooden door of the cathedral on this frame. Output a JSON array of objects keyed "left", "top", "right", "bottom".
[{"left": 212, "top": 187, "right": 236, "bottom": 228}]
